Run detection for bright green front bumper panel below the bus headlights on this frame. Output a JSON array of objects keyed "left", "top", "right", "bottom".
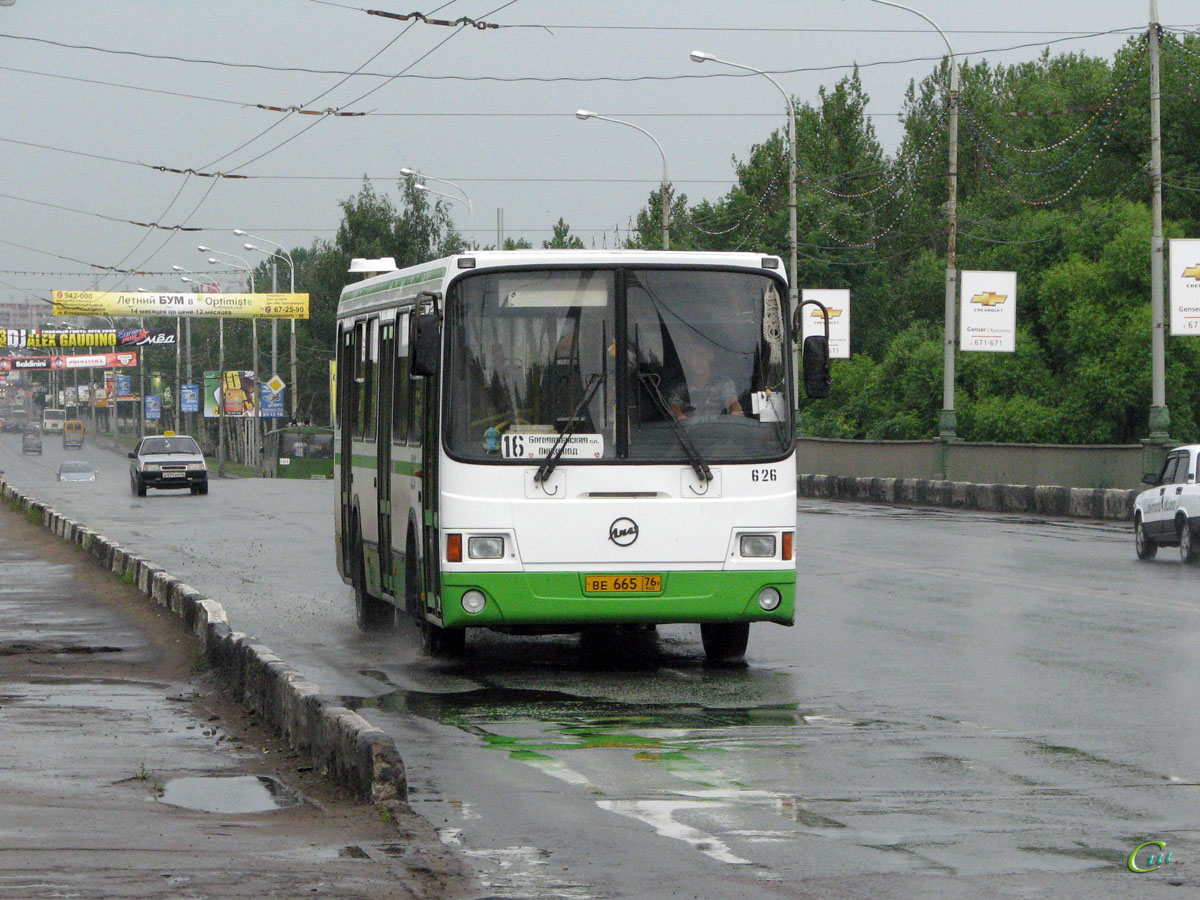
[{"left": 442, "top": 566, "right": 796, "bottom": 628}]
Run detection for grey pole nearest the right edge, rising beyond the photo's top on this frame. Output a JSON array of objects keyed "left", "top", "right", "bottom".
[{"left": 1144, "top": 0, "right": 1171, "bottom": 472}]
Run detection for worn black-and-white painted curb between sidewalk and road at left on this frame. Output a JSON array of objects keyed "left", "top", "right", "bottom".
[{"left": 0, "top": 480, "right": 408, "bottom": 805}]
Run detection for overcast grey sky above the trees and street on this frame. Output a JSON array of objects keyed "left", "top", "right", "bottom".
[{"left": 0, "top": 0, "right": 1180, "bottom": 302}]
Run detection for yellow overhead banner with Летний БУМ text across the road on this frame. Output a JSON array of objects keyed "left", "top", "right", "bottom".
[{"left": 53, "top": 290, "right": 308, "bottom": 319}]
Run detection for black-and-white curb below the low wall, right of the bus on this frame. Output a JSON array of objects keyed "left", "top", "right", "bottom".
[{"left": 796, "top": 475, "right": 1139, "bottom": 521}]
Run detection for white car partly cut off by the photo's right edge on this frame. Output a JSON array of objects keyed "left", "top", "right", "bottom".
[{"left": 1133, "top": 444, "right": 1200, "bottom": 563}]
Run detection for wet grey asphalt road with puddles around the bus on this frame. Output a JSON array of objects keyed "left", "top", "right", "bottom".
[{"left": 0, "top": 436, "right": 1200, "bottom": 898}]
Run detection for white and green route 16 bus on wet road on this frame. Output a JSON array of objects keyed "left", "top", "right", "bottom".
[{"left": 335, "top": 250, "right": 828, "bottom": 659}]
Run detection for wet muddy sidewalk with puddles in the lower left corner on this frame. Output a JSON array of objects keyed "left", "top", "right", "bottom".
[{"left": 0, "top": 503, "right": 478, "bottom": 900}]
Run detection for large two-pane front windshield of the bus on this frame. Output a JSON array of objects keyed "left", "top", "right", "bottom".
[{"left": 444, "top": 268, "right": 793, "bottom": 464}]
